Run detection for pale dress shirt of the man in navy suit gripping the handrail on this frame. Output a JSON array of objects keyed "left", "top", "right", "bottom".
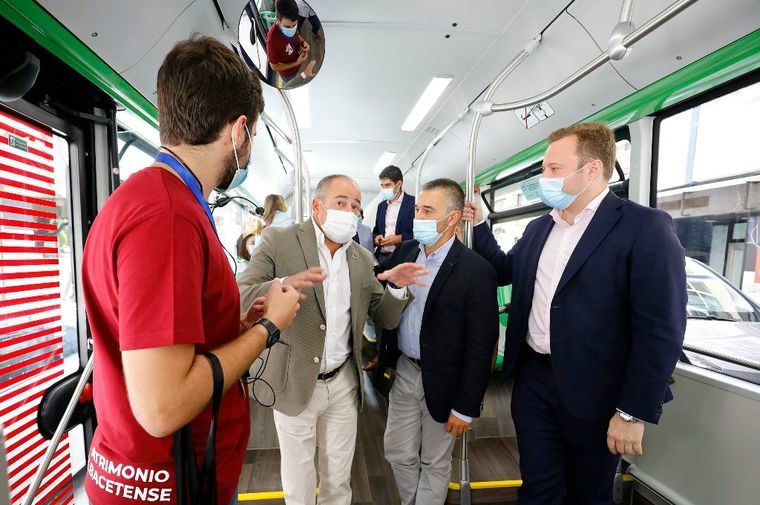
[{"left": 527, "top": 188, "right": 610, "bottom": 354}]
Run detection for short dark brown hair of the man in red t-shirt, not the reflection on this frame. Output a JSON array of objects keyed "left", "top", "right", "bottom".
[{"left": 157, "top": 35, "right": 264, "bottom": 146}]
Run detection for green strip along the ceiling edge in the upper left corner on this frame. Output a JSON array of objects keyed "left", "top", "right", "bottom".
[{"left": 0, "top": 0, "right": 158, "bottom": 127}]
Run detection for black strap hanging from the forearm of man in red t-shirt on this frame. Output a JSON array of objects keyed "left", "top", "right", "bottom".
[{"left": 174, "top": 351, "right": 224, "bottom": 505}]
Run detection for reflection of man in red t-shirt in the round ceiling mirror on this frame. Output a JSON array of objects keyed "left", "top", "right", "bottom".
[{"left": 267, "top": 0, "right": 309, "bottom": 82}]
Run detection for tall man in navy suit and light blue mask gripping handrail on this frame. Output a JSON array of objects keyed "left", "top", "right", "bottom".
[{"left": 465, "top": 123, "right": 686, "bottom": 505}]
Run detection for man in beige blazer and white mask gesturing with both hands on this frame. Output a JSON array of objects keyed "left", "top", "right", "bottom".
[{"left": 238, "top": 175, "right": 426, "bottom": 505}]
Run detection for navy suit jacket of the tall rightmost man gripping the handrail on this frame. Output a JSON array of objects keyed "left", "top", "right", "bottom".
[{"left": 474, "top": 193, "right": 686, "bottom": 423}]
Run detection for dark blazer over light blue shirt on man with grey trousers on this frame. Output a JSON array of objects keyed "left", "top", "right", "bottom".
[{"left": 373, "top": 239, "right": 499, "bottom": 423}]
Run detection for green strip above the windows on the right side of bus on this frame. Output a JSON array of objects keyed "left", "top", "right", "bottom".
[{"left": 475, "top": 29, "right": 760, "bottom": 184}]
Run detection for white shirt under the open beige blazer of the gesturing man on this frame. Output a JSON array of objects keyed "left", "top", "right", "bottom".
[{"left": 312, "top": 219, "right": 352, "bottom": 373}]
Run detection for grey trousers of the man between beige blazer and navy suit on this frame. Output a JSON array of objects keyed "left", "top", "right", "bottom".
[{"left": 385, "top": 355, "right": 455, "bottom": 505}]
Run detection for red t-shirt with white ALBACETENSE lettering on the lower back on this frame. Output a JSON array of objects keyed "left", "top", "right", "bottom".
[{"left": 83, "top": 167, "right": 250, "bottom": 505}]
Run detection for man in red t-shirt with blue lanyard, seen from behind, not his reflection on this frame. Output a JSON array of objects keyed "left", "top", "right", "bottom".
[{"left": 83, "top": 37, "right": 299, "bottom": 505}]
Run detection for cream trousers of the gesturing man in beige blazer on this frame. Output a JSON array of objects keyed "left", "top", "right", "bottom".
[{"left": 274, "top": 361, "right": 359, "bottom": 505}]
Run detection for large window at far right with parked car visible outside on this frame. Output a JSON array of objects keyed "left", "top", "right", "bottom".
[{"left": 657, "top": 83, "right": 760, "bottom": 384}]
